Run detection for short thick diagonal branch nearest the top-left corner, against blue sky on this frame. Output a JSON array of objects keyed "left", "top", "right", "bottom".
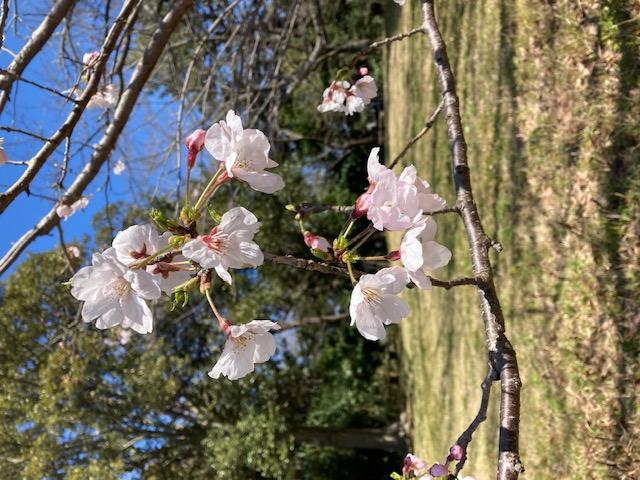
[{"left": 0, "top": 0, "right": 75, "bottom": 113}]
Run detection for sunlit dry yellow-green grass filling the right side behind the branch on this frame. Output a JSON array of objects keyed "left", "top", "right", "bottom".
[{"left": 385, "top": 0, "right": 640, "bottom": 479}]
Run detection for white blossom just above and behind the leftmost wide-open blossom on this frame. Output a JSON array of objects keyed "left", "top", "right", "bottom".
[{"left": 112, "top": 224, "right": 191, "bottom": 295}]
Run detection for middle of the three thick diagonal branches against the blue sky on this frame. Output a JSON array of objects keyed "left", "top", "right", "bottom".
[{"left": 0, "top": 0, "right": 140, "bottom": 213}]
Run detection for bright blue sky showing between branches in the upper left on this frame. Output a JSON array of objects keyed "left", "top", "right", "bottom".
[{"left": 0, "top": 1, "right": 194, "bottom": 278}]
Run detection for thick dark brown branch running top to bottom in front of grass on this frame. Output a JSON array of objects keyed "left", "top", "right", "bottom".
[{"left": 422, "top": 0, "right": 524, "bottom": 480}]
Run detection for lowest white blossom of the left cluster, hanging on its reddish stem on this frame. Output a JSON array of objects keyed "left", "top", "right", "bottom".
[{"left": 209, "top": 320, "right": 280, "bottom": 380}]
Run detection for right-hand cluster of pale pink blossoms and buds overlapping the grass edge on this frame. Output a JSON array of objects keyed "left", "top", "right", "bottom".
[{"left": 304, "top": 147, "right": 451, "bottom": 340}]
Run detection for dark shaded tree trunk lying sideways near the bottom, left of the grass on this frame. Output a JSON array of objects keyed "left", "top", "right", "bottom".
[{"left": 293, "top": 424, "right": 407, "bottom": 452}]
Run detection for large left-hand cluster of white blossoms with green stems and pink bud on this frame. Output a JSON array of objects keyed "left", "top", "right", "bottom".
[{"left": 68, "top": 109, "right": 284, "bottom": 380}]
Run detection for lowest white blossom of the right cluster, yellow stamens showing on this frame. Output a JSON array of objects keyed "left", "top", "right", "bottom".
[{"left": 349, "top": 267, "right": 409, "bottom": 340}]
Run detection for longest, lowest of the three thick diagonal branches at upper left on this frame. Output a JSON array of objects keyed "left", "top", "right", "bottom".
[{"left": 0, "top": 0, "right": 194, "bottom": 274}]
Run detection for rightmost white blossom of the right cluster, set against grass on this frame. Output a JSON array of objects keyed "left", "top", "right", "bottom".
[{"left": 400, "top": 217, "right": 451, "bottom": 290}]
